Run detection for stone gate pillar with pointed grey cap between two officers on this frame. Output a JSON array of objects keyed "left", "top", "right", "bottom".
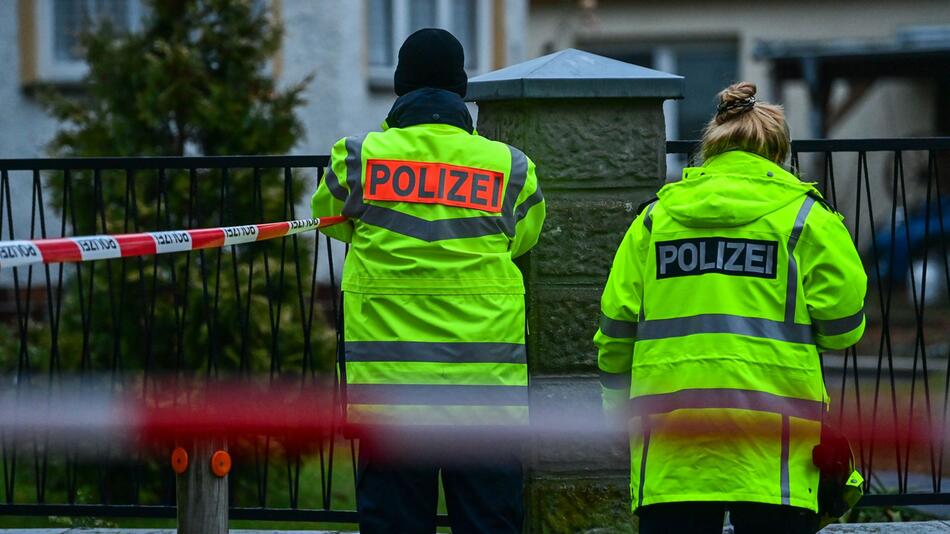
[{"left": 468, "top": 49, "right": 683, "bottom": 532}]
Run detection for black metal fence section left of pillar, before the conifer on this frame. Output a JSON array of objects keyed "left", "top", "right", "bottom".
[{"left": 0, "top": 156, "right": 356, "bottom": 522}]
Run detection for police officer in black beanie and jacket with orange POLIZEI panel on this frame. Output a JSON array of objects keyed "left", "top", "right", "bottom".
[{"left": 312, "top": 29, "right": 545, "bottom": 533}]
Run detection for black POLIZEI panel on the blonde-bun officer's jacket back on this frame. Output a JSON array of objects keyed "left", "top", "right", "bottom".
[{"left": 655, "top": 237, "right": 778, "bottom": 279}]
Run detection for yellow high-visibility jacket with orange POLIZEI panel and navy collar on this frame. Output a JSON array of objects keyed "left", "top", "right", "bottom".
[{"left": 312, "top": 89, "right": 545, "bottom": 430}]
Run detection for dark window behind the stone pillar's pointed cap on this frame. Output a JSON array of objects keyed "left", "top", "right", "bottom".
[{"left": 584, "top": 40, "right": 739, "bottom": 178}]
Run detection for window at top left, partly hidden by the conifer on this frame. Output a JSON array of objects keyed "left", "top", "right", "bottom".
[{"left": 35, "top": 0, "right": 143, "bottom": 83}]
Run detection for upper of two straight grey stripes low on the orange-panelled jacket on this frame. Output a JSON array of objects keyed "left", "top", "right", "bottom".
[{"left": 346, "top": 341, "right": 528, "bottom": 364}]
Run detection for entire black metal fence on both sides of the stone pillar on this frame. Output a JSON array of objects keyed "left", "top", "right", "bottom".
[{"left": 0, "top": 138, "right": 950, "bottom": 522}]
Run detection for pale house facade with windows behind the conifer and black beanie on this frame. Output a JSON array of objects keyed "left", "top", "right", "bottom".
[{"left": 0, "top": 0, "right": 527, "bottom": 157}]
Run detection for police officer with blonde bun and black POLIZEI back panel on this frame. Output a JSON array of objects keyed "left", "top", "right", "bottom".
[{"left": 594, "top": 83, "right": 867, "bottom": 534}]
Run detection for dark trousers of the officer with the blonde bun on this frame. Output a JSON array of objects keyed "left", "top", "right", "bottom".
[{"left": 637, "top": 502, "right": 818, "bottom": 534}]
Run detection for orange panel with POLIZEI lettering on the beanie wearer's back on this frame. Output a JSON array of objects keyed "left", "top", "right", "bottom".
[{"left": 363, "top": 159, "right": 505, "bottom": 213}]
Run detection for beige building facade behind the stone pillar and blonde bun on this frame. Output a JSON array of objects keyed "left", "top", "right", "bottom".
[{"left": 527, "top": 0, "right": 950, "bottom": 144}]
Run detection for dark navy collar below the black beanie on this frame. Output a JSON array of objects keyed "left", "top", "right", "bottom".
[{"left": 383, "top": 87, "right": 475, "bottom": 133}]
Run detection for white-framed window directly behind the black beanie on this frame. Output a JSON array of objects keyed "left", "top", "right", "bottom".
[{"left": 367, "top": 0, "right": 492, "bottom": 89}]
